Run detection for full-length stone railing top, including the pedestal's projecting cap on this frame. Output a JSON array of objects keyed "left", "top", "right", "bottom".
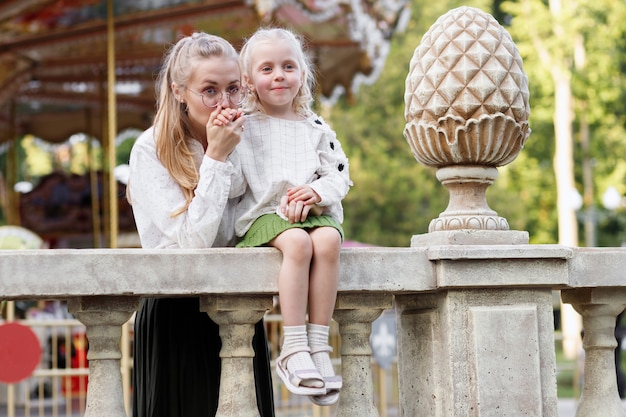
[{"left": 0, "top": 244, "right": 626, "bottom": 300}]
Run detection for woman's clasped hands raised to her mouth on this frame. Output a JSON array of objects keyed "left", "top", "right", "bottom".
[{"left": 205, "top": 106, "right": 246, "bottom": 162}]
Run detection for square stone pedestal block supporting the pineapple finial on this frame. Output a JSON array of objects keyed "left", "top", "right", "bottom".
[{"left": 395, "top": 231, "right": 571, "bottom": 417}]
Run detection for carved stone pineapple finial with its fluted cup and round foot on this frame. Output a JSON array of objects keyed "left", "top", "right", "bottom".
[{"left": 404, "top": 7, "right": 530, "bottom": 232}]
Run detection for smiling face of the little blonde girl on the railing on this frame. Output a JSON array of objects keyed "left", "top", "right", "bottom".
[{"left": 245, "top": 40, "right": 304, "bottom": 118}]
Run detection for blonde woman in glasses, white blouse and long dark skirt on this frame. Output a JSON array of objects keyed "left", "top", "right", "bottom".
[{"left": 128, "top": 33, "right": 274, "bottom": 417}]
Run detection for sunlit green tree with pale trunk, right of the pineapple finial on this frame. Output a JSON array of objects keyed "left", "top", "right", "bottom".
[{"left": 503, "top": 0, "right": 626, "bottom": 245}]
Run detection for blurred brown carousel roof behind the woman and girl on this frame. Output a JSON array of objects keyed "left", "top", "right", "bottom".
[{"left": 0, "top": 0, "right": 408, "bottom": 144}]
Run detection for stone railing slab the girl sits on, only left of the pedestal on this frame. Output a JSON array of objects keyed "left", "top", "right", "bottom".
[{"left": 0, "top": 247, "right": 428, "bottom": 299}]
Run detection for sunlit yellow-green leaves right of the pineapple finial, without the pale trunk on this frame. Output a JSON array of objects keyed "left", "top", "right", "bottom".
[{"left": 503, "top": 0, "right": 626, "bottom": 245}]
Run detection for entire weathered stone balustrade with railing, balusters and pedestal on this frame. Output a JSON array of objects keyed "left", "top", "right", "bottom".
[{"left": 0, "top": 242, "right": 626, "bottom": 417}]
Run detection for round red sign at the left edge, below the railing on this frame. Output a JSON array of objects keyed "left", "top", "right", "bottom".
[{"left": 0, "top": 323, "right": 41, "bottom": 384}]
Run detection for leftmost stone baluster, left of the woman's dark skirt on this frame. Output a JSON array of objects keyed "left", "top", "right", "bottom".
[{"left": 68, "top": 296, "right": 139, "bottom": 417}]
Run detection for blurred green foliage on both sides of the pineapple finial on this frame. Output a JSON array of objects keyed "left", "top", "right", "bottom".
[{"left": 329, "top": 0, "right": 626, "bottom": 246}]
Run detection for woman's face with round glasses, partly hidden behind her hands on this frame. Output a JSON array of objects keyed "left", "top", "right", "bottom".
[{"left": 180, "top": 57, "right": 241, "bottom": 134}]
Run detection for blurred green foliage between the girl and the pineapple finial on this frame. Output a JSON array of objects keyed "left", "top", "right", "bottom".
[{"left": 322, "top": 1, "right": 464, "bottom": 246}]
